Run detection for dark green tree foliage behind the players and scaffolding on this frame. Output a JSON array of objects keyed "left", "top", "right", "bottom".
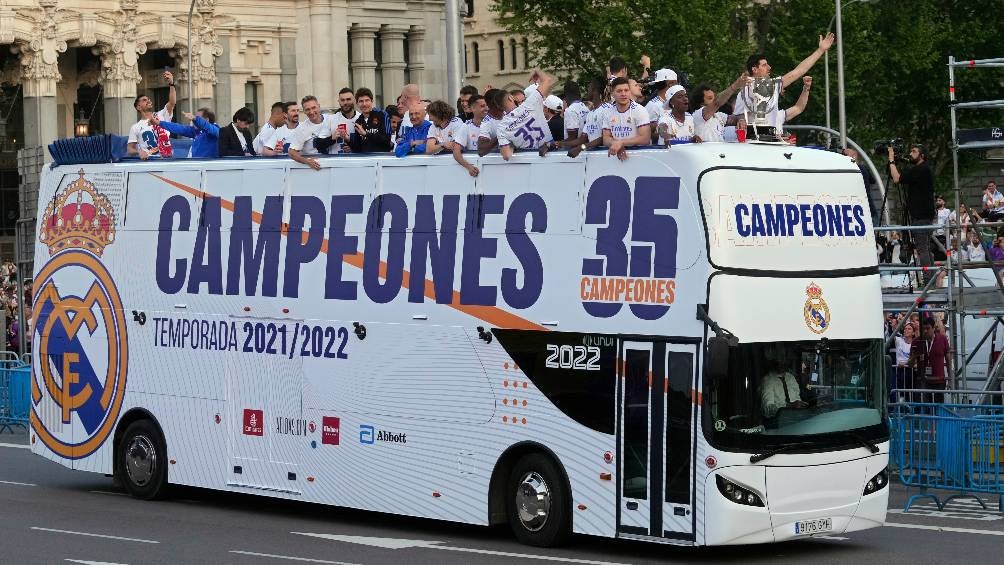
[{"left": 493, "top": 0, "right": 1004, "bottom": 192}]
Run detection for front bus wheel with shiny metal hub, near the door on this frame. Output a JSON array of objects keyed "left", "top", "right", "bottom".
[{"left": 506, "top": 453, "right": 571, "bottom": 547}]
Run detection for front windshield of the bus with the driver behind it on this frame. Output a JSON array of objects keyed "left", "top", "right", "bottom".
[{"left": 708, "top": 338, "right": 887, "bottom": 450}]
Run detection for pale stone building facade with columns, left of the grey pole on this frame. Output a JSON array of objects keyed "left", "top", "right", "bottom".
[{"left": 0, "top": 0, "right": 446, "bottom": 258}]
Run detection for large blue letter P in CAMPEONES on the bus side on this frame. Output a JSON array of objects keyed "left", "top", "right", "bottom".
[{"left": 282, "top": 196, "right": 327, "bottom": 298}]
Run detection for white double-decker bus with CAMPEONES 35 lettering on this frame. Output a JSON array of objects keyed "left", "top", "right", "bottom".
[{"left": 31, "top": 144, "right": 889, "bottom": 545}]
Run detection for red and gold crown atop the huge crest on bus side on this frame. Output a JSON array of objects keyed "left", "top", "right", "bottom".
[{"left": 38, "top": 169, "right": 115, "bottom": 257}]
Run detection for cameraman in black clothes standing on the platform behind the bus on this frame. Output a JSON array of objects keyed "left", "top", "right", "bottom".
[{"left": 889, "top": 144, "right": 935, "bottom": 283}]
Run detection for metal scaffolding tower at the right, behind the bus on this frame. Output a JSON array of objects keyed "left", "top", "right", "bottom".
[{"left": 876, "top": 56, "right": 1004, "bottom": 402}]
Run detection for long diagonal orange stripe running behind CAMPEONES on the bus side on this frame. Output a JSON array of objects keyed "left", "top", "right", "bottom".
[{"left": 151, "top": 173, "right": 549, "bottom": 331}]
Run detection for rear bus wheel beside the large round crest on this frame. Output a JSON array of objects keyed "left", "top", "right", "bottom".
[{"left": 115, "top": 419, "right": 168, "bottom": 500}]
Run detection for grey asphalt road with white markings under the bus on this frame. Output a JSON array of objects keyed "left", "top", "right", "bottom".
[{"left": 0, "top": 434, "right": 1004, "bottom": 565}]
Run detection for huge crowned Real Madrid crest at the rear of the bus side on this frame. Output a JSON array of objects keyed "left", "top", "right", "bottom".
[{"left": 30, "top": 169, "right": 129, "bottom": 460}]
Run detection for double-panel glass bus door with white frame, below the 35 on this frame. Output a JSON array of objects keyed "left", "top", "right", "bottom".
[{"left": 617, "top": 341, "right": 698, "bottom": 540}]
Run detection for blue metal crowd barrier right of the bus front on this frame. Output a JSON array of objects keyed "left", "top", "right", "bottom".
[{"left": 890, "top": 402, "right": 1004, "bottom": 512}]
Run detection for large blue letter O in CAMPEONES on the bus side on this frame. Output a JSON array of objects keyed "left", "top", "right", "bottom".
[{"left": 362, "top": 194, "right": 407, "bottom": 304}]
